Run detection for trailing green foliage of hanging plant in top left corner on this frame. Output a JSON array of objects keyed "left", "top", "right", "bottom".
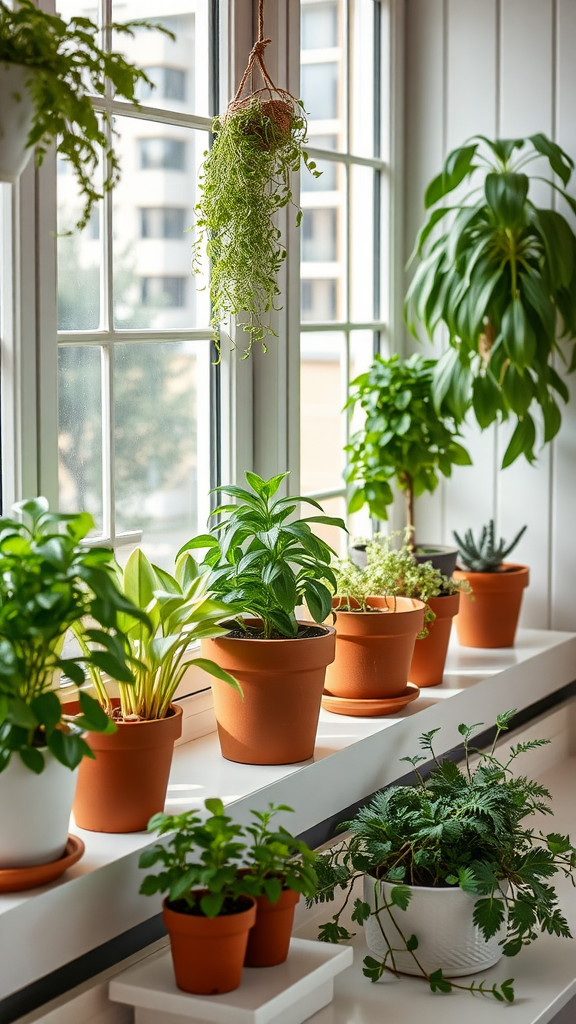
[{"left": 0, "top": 0, "right": 170, "bottom": 229}]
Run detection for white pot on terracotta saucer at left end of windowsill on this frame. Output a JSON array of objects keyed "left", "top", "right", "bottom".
[{"left": 0, "top": 751, "right": 78, "bottom": 868}]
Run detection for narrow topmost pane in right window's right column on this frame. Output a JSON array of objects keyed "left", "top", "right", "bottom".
[{"left": 351, "top": 0, "right": 378, "bottom": 157}]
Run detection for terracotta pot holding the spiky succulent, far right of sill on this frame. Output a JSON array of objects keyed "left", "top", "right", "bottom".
[{"left": 454, "top": 562, "right": 530, "bottom": 647}]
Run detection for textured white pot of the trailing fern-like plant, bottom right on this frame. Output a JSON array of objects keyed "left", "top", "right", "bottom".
[{"left": 364, "top": 876, "right": 506, "bottom": 978}]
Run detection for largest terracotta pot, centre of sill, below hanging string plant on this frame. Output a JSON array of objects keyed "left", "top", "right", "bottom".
[{"left": 202, "top": 620, "right": 335, "bottom": 765}]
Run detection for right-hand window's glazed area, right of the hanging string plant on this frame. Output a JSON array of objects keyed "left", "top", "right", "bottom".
[{"left": 300, "top": 0, "right": 388, "bottom": 550}]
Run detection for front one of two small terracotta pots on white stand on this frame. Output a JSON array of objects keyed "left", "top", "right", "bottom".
[{"left": 162, "top": 896, "right": 256, "bottom": 995}]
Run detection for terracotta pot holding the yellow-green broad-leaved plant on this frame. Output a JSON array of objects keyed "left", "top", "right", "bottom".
[{"left": 68, "top": 698, "right": 182, "bottom": 833}]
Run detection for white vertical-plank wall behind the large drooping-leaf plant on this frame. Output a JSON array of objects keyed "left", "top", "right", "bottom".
[{"left": 403, "top": 0, "right": 576, "bottom": 630}]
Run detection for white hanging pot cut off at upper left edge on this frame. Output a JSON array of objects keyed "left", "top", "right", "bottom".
[{"left": 0, "top": 61, "right": 33, "bottom": 182}]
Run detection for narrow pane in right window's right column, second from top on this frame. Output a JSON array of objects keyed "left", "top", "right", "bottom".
[{"left": 349, "top": 165, "right": 375, "bottom": 323}]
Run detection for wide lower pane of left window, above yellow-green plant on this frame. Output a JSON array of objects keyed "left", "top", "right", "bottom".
[{"left": 115, "top": 342, "right": 206, "bottom": 569}]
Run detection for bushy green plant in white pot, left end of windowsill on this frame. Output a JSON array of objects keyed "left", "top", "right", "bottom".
[{"left": 0, "top": 498, "right": 146, "bottom": 884}]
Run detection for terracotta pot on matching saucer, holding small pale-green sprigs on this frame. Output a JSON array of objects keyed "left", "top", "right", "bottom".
[{"left": 325, "top": 597, "right": 424, "bottom": 700}]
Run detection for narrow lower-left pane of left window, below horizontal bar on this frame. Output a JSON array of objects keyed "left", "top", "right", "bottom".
[{"left": 58, "top": 345, "right": 102, "bottom": 534}]
